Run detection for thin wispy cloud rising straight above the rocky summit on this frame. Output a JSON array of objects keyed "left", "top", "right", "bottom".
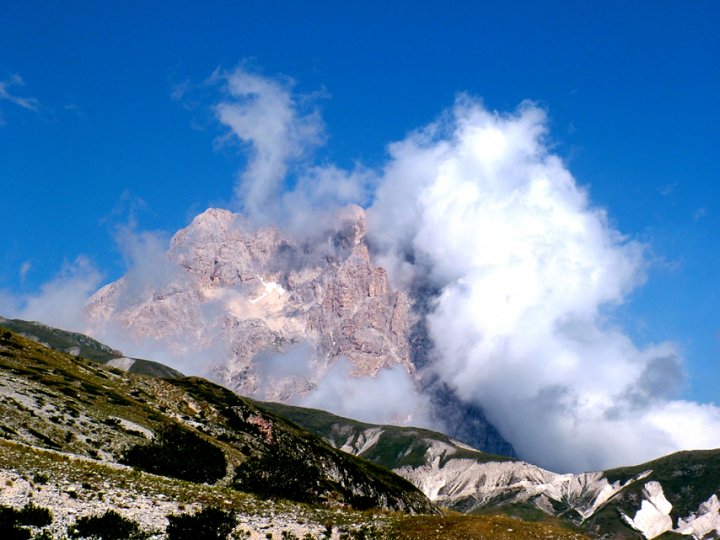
[{"left": 212, "top": 68, "right": 377, "bottom": 238}]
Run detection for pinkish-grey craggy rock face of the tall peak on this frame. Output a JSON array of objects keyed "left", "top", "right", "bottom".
[{"left": 87, "top": 207, "right": 414, "bottom": 401}]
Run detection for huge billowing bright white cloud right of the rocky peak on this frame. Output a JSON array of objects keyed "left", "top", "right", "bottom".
[{"left": 369, "top": 96, "right": 720, "bottom": 471}]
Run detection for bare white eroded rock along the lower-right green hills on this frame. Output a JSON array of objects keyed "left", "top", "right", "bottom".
[{"left": 327, "top": 426, "right": 720, "bottom": 540}]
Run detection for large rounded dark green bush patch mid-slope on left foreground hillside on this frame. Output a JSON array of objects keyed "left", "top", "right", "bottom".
[{"left": 121, "top": 424, "right": 227, "bottom": 484}]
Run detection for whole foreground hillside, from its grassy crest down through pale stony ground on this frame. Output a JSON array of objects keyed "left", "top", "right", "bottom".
[{"left": 0, "top": 325, "right": 596, "bottom": 540}]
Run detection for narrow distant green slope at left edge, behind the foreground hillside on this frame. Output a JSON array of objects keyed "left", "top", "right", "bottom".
[{"left": 0, "top": 317, "right": 184, "bottom": 379}]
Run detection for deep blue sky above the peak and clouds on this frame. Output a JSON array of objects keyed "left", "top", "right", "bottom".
[{"left": 0, "top": 1, "right": 720, "bottom": 402}]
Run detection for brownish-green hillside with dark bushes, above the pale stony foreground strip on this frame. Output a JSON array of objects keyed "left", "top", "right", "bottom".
[{"left": 0, "top": 331, "right": 437, "bottom": 513}]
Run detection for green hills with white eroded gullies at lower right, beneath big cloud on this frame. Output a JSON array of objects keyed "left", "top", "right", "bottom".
[{"left": 261, "top": 403, "right": 720, "bottom": 538}]
